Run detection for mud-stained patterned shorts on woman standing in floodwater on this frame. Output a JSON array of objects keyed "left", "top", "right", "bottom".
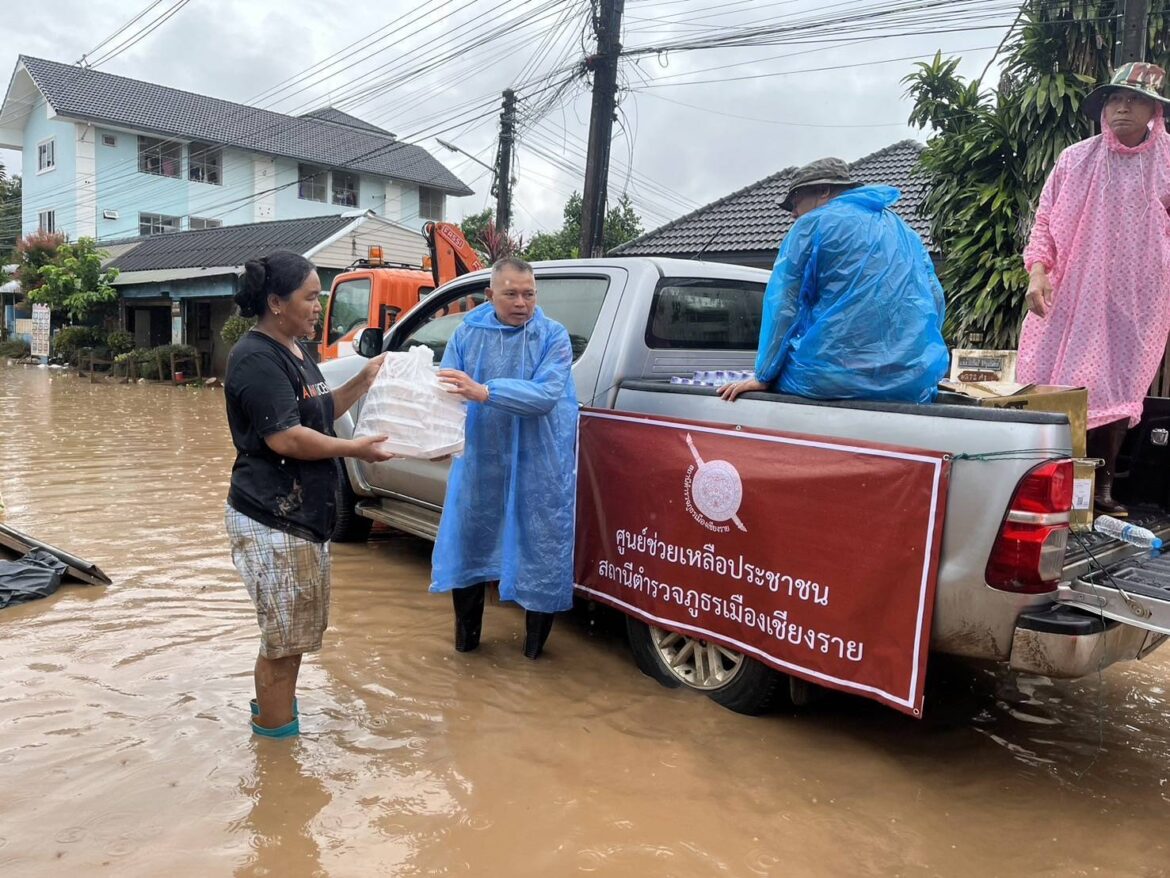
[{"left": 225, "top": 506, "right": 329, "bottom": 659}]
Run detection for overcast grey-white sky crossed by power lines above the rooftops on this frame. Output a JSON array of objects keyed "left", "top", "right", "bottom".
[{"left": 0, "top": 0, "right": 1013, "bottom": 235}]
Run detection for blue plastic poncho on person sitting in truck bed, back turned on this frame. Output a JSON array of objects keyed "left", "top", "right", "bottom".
[{"left": 756, "top": 186, "right": 949, "bottom": 403}]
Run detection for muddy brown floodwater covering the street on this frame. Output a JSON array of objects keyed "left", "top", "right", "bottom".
[{"left": 0, "top": 366, "right": 1170, "bottom": 878}]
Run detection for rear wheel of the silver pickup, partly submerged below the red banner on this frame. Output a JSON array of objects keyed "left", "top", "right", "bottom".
[{"left": 626, "top": 616, "right": 789, "bottom": 716}]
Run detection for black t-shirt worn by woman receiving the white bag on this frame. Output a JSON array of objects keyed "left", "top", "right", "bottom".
[{"left": 223, "top": 331, "right": 338, "bottom": 543}]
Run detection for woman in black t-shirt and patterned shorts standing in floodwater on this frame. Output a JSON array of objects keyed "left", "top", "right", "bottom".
[{"left": 223, "top": 251, "right": 392, "bottom": 738}]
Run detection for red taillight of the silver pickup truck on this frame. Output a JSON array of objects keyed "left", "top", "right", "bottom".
[{"left": 985, "top": 460, "right": 1073, "bottom": 595}]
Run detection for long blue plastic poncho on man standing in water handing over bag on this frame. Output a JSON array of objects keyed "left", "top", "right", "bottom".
[{"left": 431, "top": 302, "right": 577, "bottom": 612}]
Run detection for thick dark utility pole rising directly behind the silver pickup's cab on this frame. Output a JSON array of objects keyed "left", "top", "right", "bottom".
[{"left": 580, "top": 0, "right": 625, "bottom": 258}]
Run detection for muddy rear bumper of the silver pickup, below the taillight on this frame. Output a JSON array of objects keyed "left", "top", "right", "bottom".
[{"left": 1010, "top": 605, "right": 1166, "bottom": 679}]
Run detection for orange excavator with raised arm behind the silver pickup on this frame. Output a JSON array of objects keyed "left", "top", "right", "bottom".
[{"left": 321, "top": 222, "right": 483, "bottom": 361}]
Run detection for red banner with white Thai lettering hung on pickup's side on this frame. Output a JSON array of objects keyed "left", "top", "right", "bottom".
[{"left": 576, "top": 410, "right": 950, "bottom": 716}]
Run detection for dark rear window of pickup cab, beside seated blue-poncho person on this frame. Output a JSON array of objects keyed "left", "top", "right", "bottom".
[{"left": 646, "top": 277, "right": 764, "bottom": 351}]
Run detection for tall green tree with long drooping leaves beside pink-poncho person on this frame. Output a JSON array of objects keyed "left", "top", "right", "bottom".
[{"left": 904, "top": 0, "right": 1170, "bottom": 348}]
